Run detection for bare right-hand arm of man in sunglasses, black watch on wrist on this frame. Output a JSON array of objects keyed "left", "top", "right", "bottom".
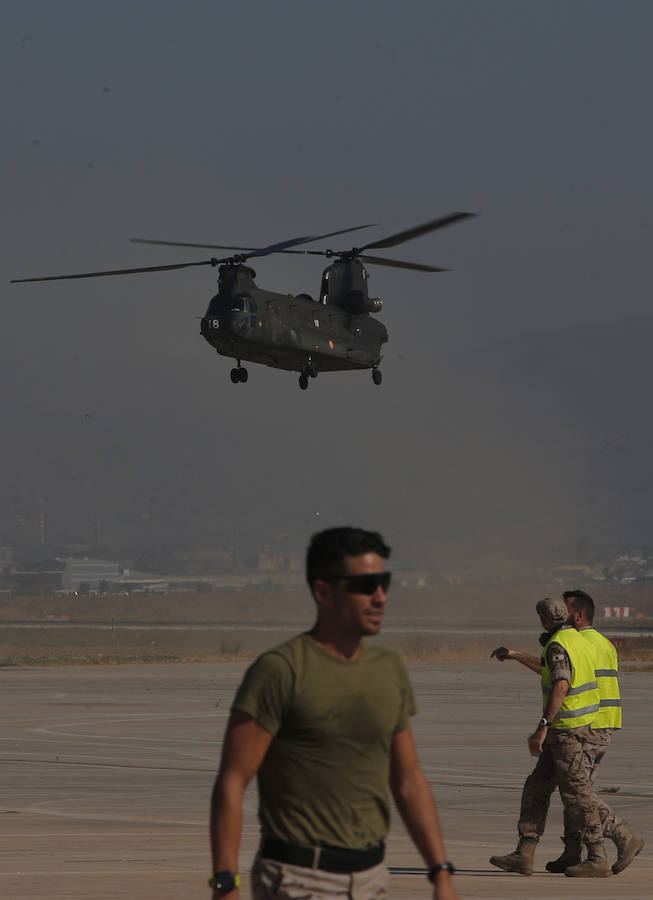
[{"left": 390, "top": 728, "right": 458, "bottom": 900}]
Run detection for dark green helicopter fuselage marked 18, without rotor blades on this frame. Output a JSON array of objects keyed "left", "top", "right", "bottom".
[{"left": 201, "top": 260, "right": 388, "bottom": 372}]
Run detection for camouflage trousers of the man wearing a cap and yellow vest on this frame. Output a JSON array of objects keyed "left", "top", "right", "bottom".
[{"left": 518, "top": 726, "right": 611, "bottom": 844}]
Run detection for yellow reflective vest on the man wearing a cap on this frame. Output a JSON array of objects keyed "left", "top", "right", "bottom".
[{"left": 542, "top": 626, "right": 600, "bottom": 728}]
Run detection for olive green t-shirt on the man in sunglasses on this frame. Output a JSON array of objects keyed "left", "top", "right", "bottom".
[{"left": 232, "top": 634, "right": 416, "bottom": 850}]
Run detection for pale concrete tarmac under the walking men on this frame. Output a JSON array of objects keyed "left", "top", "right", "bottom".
[{"left": 0, "top": 660, "right": 653, "bottom": 900}]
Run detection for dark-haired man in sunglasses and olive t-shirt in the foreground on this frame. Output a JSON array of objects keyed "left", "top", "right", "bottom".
[{"left": 209, "top": 528, "right": 457, "bottom": 900}]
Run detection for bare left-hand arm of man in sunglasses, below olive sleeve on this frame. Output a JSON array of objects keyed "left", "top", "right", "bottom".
[{"left": 210, "top": 711, "right": 272, "bottom": 900}]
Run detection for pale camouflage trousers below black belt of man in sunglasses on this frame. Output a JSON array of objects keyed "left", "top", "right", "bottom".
[{"left": 251, "top": 856, "right": 388, "bottom": 900}]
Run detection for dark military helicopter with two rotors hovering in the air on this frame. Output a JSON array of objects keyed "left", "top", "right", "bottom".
[{"left": 12, "top": 212, "right": 474, "bottom": 390}]
